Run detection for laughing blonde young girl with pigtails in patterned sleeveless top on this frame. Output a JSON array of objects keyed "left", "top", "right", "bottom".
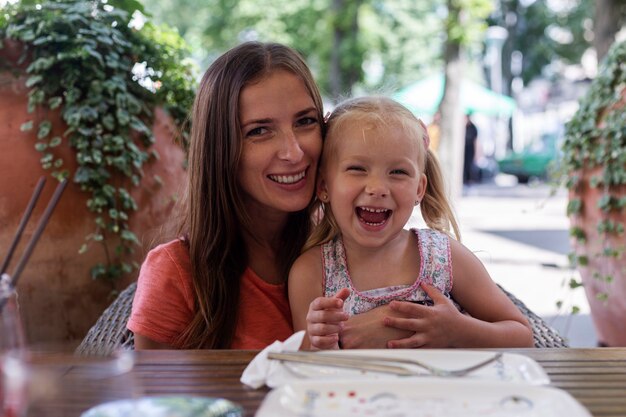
[{"left": 289, "top": 97, "right": 533, "bottom": 349}]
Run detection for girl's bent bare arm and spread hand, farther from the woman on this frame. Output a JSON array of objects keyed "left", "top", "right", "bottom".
[{"left": 385, "top": 240, "right": 533, "bottom": 348}]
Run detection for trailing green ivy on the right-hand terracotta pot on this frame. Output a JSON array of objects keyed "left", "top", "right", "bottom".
[{"left": 562, "top": 41, "right": 626, "bottom": 299}]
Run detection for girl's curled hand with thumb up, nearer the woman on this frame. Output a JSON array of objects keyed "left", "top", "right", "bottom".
[{"left": 306, "top": 288, "right": 350, "bottom": 349}]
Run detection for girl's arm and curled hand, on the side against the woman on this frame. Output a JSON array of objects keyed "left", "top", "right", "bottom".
[{"left": 288, "top": 247, "right": 350, "bottom": 349}]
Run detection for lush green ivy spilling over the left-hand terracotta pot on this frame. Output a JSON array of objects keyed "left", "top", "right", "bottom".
[{"left": 0, "top": 0, "right": 194, "bottom": 283}]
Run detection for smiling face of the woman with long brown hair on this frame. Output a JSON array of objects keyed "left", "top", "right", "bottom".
[{"left": 238, "top": 70, "right": 322, "bottom": 218}]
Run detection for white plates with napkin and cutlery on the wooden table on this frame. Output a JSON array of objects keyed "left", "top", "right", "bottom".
[{"left": 241, "top": 332, "right": 591, "bottom": 417}]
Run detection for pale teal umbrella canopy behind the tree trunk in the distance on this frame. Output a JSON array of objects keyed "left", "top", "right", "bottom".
[{"left": 393, "top": 74, "right": 516, "bottom": 117}]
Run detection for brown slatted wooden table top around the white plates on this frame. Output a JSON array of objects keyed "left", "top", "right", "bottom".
[{"left": 130, "top": 348, "right": 626, "bottom": 417}]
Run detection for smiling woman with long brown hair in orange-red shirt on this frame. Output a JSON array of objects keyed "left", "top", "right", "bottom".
[{"left": 128, "top": 42, "right": 323, "bottom": 349}]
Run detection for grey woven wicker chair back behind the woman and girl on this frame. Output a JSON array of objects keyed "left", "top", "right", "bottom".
[{"left": 76, "top": 283, "right": 568, "bottom": 354}]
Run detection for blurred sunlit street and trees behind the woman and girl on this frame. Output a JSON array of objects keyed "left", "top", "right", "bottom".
[{"left": 0, "top": 0, "right": 626, "bottom": 346}]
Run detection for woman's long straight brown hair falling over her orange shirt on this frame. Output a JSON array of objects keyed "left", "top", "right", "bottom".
[{"left": 177, "top": 42, "right": 323, "bottom": 349}]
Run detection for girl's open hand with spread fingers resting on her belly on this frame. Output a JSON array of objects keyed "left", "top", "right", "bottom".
[{"left": 384, "top": 283, "right": 465, "bottom": 349}]
